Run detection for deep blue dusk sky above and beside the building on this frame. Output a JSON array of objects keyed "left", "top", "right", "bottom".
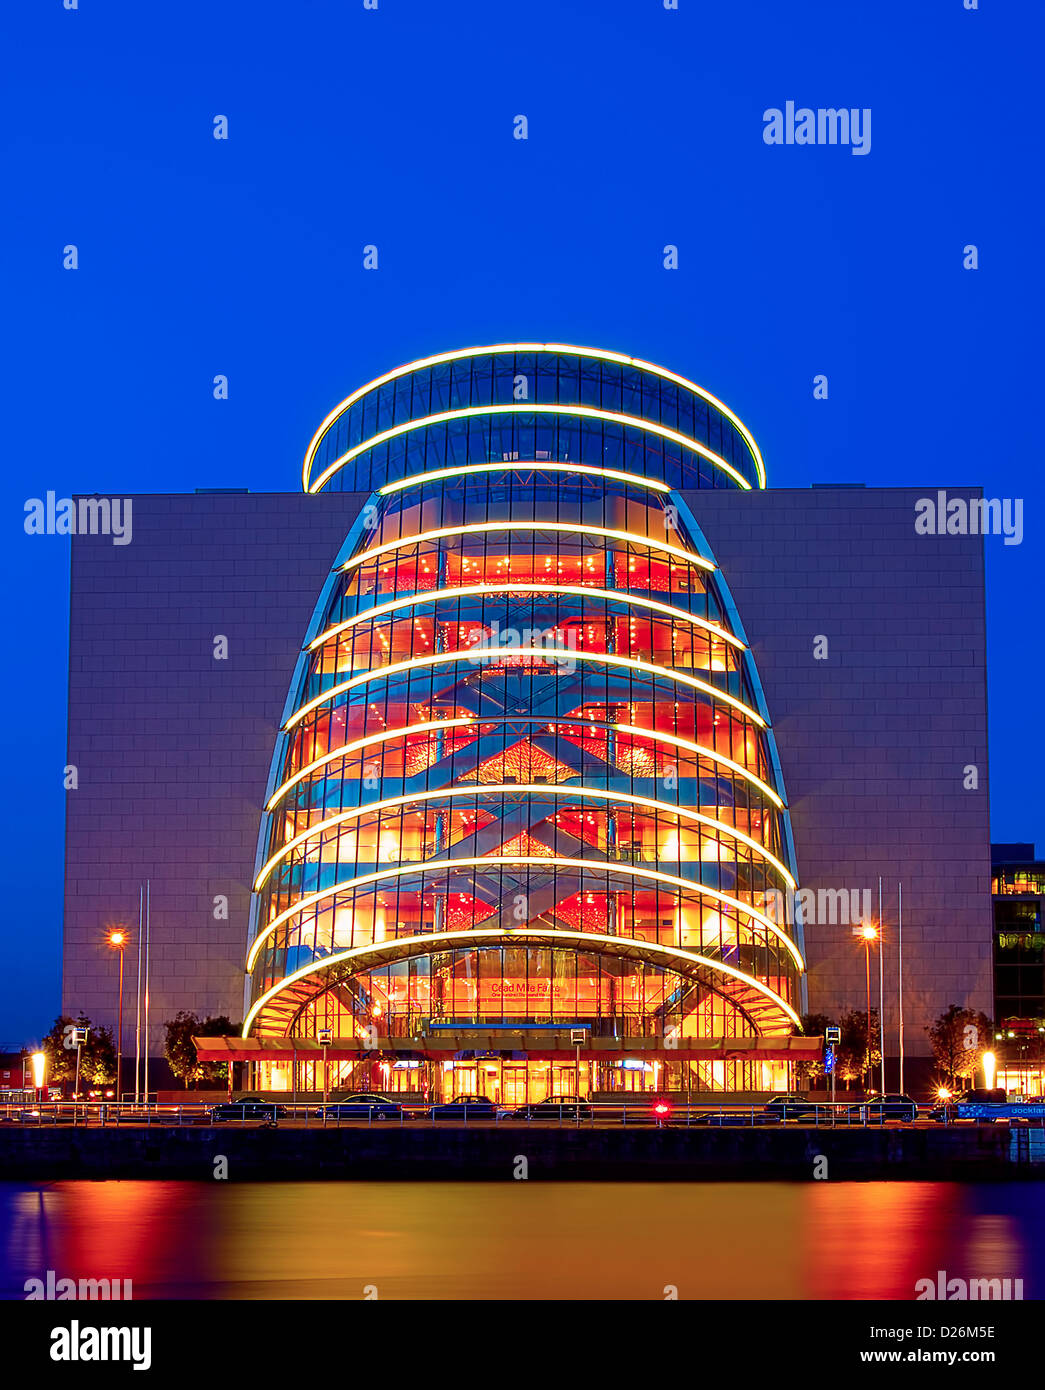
[{"left": 0, "top": 0, "right": 1045, "bottom": 1045}]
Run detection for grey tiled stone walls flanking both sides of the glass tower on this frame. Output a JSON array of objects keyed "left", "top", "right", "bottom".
[{"left": 63, "top": 489, "right": 991, "bottom": 1052}]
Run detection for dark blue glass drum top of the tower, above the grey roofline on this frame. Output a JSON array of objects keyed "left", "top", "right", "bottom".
[{"left": 303, "top": 343, "right": 766, "bottom": 492}]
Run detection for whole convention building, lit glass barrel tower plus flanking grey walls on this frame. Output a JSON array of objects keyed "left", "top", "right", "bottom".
[{"left": 64, "top": 343, "right": 991, "bottom": 1102}]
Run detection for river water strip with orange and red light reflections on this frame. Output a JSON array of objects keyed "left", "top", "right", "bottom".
[{"left": 0, "top": 1182, "right": 1045, "bottom": 1300}]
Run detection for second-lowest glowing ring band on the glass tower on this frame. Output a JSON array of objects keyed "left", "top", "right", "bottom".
[{"left": 246, "top": 855, "right": 805, "bottom": 970}]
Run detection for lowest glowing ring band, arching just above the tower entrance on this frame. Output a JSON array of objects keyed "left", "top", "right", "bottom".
[{"left": 243, "top": 927, "right": 802, "bottom": 1037}]
